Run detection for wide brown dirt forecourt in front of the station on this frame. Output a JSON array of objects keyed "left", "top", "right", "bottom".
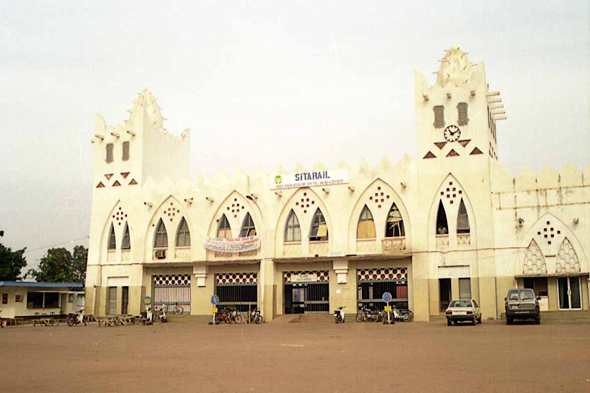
[{"left": 0, "top": 319, "right": 590, "bottom": 392}]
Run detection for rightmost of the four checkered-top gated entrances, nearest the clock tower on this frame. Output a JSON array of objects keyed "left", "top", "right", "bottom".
[{"left": 357, "top": 267, "right": 408, "bottom": 310}]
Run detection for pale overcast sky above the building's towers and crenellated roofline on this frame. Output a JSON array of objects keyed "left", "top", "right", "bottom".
[{"left": 0, "top": 0, "right": 590, "bottom": 267}]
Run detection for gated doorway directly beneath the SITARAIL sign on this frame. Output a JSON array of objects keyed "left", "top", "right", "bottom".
[{"left": 283, "top": 270, "right": 330, "bottom": 314}]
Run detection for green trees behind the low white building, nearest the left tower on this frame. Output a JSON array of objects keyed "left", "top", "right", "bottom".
[{"left": 27, "top": 246, "right": 88, "bottom": 282}]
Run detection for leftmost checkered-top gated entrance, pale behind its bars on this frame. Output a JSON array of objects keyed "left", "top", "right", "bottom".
[{"left": 152, "top": 274, "right": 191, "bottom": 314}]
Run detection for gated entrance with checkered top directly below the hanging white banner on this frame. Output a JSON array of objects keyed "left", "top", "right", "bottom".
[{"left": 215, "top": 273, "right": 258, "bottom": 311}]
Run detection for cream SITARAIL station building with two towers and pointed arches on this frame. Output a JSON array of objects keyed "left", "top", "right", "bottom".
[{"left": 85, "top": 47, "right": 590, "bottom": 321}]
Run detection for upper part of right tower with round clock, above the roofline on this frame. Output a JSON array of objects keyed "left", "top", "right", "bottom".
[{"left": 414, "top": 46, "right": 505, "bottom": 167}]
